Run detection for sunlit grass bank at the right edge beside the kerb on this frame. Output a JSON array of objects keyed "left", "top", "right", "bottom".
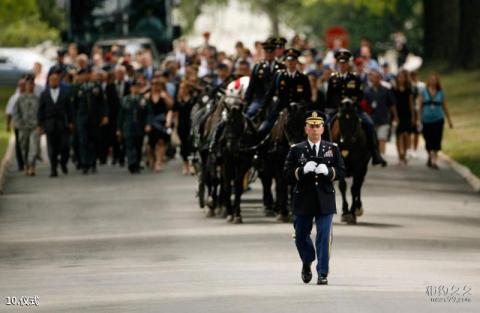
[{"left": 423, "top": 70, "right": 480, "bottom": 176}]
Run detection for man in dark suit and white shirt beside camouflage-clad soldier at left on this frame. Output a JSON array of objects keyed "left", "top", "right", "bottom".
[{"left": 38, "top": 68, "right": 73, "bottom": 177}]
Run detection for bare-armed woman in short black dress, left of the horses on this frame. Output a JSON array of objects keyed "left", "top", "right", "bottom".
[{"left": 146, "top": 78, "right": 173, "bottom": 172}]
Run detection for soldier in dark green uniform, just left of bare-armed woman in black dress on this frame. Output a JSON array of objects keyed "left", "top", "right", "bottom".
[{"left": 117, "top": 79, "right": 153, "bottom": 174}]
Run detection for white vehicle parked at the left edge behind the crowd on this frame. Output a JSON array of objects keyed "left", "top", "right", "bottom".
[{"left": 0, "top": 48, "right": 54, "bottom": 87}]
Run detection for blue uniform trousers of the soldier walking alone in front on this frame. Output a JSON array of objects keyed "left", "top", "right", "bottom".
[{"left": 293, "top": 214, "right": 333, "bottom": 276}]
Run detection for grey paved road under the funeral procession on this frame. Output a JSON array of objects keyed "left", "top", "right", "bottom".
[{"left": 0, "top": 143, "right": 480, "bottom": 313}]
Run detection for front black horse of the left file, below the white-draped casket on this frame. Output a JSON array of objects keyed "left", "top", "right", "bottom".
[{"left": 210, "top": 96, "right": 257, "bottom": 224}]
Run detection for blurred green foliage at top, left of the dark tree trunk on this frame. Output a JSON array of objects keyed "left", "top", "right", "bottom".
[{"left": 285, "top": 0, "right": 422, "bottom": 50}]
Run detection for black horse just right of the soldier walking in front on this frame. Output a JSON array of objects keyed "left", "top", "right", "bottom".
[{"left": 331, "top": 99, "right": 371, "bottom": 224}]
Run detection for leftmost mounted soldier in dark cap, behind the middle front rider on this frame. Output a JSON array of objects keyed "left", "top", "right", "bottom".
[{"left": 245, "top": 40, "right": 285, "bottom": 117}]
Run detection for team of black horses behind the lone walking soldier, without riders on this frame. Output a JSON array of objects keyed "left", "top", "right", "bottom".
[{"left": 190, "top": 77, "right": 370, "bottom": 224}]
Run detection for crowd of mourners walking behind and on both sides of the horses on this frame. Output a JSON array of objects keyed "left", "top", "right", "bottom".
[{"left": 6, "top": 32, "right": 453, "bottom": 177}]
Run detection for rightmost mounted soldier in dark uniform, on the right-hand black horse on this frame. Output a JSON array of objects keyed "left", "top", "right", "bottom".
[{"left": 325, "top": 49, "right": 387, "bottom": 166}]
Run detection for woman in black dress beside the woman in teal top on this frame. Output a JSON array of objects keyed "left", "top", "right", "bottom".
[{"left": 394, "top": 70, "right": 416, "bottom": 165}]
